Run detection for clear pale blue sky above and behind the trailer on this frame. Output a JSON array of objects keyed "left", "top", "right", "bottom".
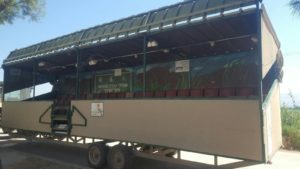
[{"left": 0, "top": 0, "right": 300, "bottom": 103}]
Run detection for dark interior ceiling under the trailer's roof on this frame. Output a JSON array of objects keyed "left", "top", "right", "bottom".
[{"left": 14, "top": 12, "right": 257, "bottom": 74}]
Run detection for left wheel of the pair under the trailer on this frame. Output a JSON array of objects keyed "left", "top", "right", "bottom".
[{"left": 87, "top": 143, "right": 108, "bottom": 168}]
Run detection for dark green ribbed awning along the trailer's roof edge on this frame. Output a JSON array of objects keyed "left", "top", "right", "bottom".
[{"left": 3, "top": 0, "right": 256, "bottom": 65}]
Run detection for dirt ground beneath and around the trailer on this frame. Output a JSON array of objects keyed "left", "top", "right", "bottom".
[{"left": 0, "top": 134, "right": 300, "bottom": 169}]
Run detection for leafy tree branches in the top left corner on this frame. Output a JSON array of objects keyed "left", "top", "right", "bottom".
[{"left": 0, "top": 0, "right": 45, "bottom": 25}]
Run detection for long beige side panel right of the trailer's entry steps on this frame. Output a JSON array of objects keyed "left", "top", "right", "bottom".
[{"left": 72, "top": 100, "right": 262, "bottom": 161}]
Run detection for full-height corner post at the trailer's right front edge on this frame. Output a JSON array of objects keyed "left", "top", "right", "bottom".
[{"left": 256, "top": 0, "right": 267, "bottom": 163}]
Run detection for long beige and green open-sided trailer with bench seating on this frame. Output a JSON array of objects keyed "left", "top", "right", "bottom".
[{"left": 2, "top": 0, "right": 283, "bottom": 169}]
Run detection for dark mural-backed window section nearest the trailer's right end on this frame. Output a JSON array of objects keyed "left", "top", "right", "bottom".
[{"left": 191, "top": 52, "right": 257, "bottom": 88}]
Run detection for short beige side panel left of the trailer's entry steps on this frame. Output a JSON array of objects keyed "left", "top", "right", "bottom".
[{"left": 2, "top": 101, "right": 53, "bottom": 132}]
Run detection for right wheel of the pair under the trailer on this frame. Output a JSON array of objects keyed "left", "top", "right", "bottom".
[{"left": 107, "top": 145, "right": 132, "bottom": 169}]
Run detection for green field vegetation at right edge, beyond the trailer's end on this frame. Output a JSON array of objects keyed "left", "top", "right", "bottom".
[{"left": 281, "top": 107, "right": 300, "bottom": 150}]
